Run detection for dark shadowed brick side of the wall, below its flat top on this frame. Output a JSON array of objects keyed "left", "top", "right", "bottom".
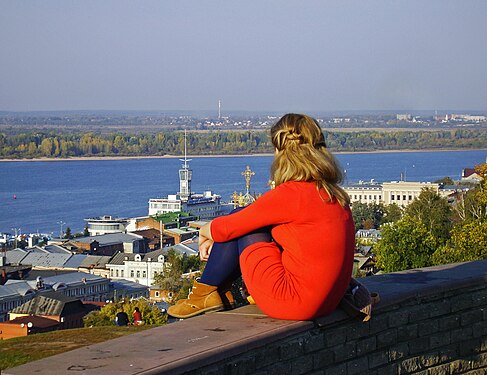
[{"left": 191, "top": 283, "right": 487, "bottom": 375}]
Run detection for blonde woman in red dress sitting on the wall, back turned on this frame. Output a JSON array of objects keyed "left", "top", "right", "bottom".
[{"left": 168, "top": 114, "right": 355, "bottom": 320}]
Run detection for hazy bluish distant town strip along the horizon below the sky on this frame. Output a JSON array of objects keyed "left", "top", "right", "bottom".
[{"left": 0, "top": 111, "right": 487, "bottom": 131}]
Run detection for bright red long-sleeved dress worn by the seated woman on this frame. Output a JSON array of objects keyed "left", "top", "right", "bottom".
[{"left": 211, "top": 181, "right": 355, "bottom": 320}]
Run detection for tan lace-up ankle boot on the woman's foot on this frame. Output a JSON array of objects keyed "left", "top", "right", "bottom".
[{"left": 167, "top": 280, "right": 224, "bottom": 319}]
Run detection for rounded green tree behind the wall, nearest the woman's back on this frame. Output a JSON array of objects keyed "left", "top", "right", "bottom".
[{"left": 374, "top": 216, "right": 438, "bottom": 272}]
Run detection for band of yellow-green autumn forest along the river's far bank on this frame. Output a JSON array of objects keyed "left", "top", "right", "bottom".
[{"left": 0, "top": 128, "right": 487, "bottom": 158}]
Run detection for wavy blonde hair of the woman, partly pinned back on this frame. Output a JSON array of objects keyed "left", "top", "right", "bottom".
[{"left": 271, "top": 113, "right": 350, "bottom": 206}]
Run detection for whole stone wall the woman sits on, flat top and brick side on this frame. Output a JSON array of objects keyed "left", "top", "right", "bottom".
[{"left": 3, "top": 260, "right": 487, "bottom": 375}]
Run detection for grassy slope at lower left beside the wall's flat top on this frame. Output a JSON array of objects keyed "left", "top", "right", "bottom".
[{"left": 0, "top": 326, "right": 155, "bottom": 371}]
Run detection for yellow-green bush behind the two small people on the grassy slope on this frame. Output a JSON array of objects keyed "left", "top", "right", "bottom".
[{"left": 83, "top": 299, "right": 167, "bottom": 327}]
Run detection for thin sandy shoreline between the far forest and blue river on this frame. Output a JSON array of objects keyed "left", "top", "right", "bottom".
[{"left": 0, "top": 148, "right": 487, "bottom": 162}]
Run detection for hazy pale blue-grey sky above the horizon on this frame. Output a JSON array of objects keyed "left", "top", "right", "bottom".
[{"left": 0, "top": 0, "right": 487, "bottom": 113}]
